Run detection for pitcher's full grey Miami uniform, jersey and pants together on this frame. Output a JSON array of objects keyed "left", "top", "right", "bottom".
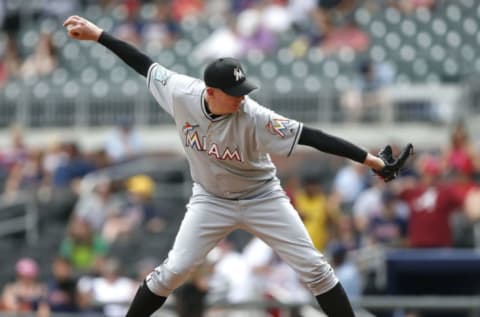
[{"left": 146, "top": 64, "right": 338, "bottom": 296}]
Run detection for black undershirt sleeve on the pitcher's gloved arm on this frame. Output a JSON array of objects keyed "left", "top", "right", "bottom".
[{"left": 298, "top": 126, "right": 368, "bottom": 163}]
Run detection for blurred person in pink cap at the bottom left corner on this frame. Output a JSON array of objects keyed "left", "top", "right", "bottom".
[{"left": 0, "top": 258, "right": 47, "bottom": 313}]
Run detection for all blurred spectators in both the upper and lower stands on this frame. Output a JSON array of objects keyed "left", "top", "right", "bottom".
[{"left": 0, "top": 0, "right": 480, "bottom": 317}]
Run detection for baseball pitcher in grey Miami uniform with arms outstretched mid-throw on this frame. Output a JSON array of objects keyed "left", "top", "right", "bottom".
[{"left": 64, "top": 16, "right": 412, "bottom": 317}]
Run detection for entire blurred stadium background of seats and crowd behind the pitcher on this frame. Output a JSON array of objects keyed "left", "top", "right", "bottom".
[{"left": 0, "top": 0, "right": 480, "bottom": 317}]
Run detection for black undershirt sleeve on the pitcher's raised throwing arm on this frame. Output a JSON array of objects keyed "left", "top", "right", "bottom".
[{"left": 98, "top": 31, "right": 153, "bottom": 77}]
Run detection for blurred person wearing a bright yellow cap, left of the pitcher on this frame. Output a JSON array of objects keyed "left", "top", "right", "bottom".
[{"left": 103, "top": 175, "right": 165, "bottom": 242}]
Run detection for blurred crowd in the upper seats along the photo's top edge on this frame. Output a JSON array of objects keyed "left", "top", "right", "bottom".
[{"left": 0, "top": 0, "right": 435, "bottom": 85}]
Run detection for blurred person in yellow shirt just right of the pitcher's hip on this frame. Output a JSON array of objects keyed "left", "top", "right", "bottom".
[{"left": 294, "top": 175, "right": 338, "bottom": 251}]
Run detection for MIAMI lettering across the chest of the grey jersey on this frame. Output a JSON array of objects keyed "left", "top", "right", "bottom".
[{"left": 182, "top": 122, "right": 243, "bottom": 162}]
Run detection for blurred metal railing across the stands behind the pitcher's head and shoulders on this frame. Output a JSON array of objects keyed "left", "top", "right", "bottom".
[{"left": 0, "top": 79, "right": 466, "bottom": 128}]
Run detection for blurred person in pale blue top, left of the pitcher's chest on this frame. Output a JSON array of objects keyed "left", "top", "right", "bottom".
[{"left": 105, "top": 118, "right": 143, "bottom": 163}]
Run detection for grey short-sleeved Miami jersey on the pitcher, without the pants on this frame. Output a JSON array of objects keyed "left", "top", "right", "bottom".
[{"left": 147, "top": 63, "right": 302, "bottom": 199}]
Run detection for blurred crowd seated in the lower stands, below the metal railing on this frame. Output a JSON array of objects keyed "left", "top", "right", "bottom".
[{"left": 0, "top": 117, "right": 480, "bottom": 316}]
